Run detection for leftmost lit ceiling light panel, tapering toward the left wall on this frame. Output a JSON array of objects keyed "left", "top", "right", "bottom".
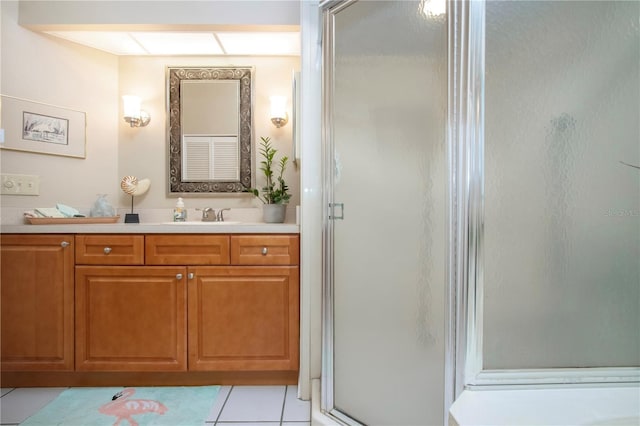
[{"left": 45, "top": 31, "right": 147, "bottom": 55}]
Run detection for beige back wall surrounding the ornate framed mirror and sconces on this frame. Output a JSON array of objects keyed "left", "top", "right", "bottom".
[{"left": 118, "top": 56, "right": 300, "bottom": 208}]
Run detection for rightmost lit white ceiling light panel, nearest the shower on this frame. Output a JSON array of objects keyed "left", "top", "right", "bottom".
[{"left": 216, "top": 32, "right": 300, "bottom": 56}]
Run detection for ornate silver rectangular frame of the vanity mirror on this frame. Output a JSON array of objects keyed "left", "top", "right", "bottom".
[{"left": 166, "top": 67, "right": 253, "bottom": 196}]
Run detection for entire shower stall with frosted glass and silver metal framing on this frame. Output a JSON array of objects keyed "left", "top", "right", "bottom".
[{"left": 320, "top": 0, "right": 640, "bottom": 425}]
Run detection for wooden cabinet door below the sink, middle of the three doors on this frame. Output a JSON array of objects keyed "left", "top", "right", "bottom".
[{"left": 76, "top": 266, "right": 187, "bottom": 371}]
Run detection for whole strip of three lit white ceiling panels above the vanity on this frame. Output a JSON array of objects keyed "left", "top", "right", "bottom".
[{"left": 43, "top": 30, "right": 300, "bottom": 56}]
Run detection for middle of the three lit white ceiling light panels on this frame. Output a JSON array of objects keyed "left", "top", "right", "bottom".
[{"left": 130, "top": 32, "right": 224, "bottom": 55}]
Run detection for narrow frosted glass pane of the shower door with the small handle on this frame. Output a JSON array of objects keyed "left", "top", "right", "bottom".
[{"left": 332, "top": 1, "right": 447, "bottom": 425}]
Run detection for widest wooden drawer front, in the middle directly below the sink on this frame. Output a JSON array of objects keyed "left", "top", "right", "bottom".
[{"left": 145, "top": 234, "right": 229, "bottom": 265}]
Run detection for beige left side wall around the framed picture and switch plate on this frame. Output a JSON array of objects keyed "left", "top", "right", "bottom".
[{"left": 0, "top": 1, "right": 119, "bottom": 207}]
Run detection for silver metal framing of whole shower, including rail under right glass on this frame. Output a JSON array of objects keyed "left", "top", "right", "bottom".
[{"left": 319, "top": 0, "right": 640, "bottom": 424}]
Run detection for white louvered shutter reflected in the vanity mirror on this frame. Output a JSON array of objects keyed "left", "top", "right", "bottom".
[{"left": 182, "top": 135, "right": 240, "bottom": 181}]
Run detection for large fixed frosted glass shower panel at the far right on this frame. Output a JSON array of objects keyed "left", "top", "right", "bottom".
[{"left": 483, "top": 1, "right": 640, "bottom": 369}]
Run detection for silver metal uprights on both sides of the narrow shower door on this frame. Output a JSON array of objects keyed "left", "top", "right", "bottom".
[{"left": 319, "top": 0, "right": 458, "bottom": 425}]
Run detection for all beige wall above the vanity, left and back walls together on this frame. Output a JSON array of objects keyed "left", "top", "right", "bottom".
[{"left": 0, "top": 1, "right": 300, "bottom": 216}]
